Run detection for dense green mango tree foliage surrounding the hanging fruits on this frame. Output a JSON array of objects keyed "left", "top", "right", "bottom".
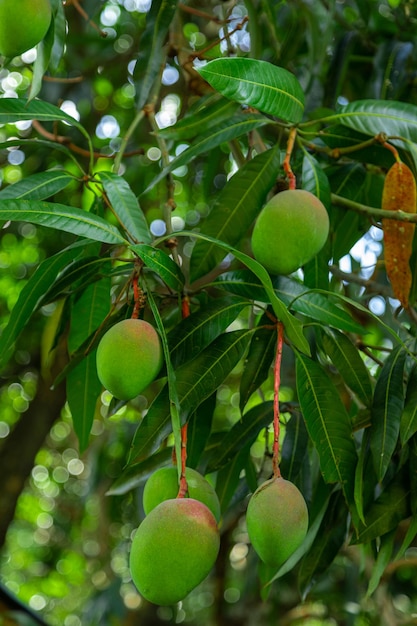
[{"left": 0, "top": 0, "right": 417, "bottom": 626}]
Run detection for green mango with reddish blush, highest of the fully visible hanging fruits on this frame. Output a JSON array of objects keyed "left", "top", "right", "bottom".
[{"left": 252, "top": 189, "right": 329, "bottom": 275}]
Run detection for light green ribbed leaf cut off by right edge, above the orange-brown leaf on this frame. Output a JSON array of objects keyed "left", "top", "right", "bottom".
[{"left": 337, "top": 100, "right": 417, "bottom": 143}]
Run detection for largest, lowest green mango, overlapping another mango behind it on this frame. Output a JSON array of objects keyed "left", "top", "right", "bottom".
[{"left": 129, "top": 498, "right": 220, "bottom": 606}]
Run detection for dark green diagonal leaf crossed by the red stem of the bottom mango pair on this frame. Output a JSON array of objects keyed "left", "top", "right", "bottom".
[{"left": 129, "top": 330, "right": 251, "bottom": 463}]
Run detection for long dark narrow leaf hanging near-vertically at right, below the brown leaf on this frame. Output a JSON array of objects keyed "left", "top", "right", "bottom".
[{"left": 369, "top": 346, "right": 406, "bottom": 480}]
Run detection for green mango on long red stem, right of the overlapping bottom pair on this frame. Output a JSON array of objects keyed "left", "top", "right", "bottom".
[{"left": 246, "top": 477, "right": 308, "bottom": 569}]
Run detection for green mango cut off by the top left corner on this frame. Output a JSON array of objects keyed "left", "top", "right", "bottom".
[{"left": 0, "top": 0, "right": 52, "bottom": 58}]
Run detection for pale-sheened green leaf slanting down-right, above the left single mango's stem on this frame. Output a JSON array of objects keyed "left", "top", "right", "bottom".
[{"left": 98, "top": 171, "right": 152, "bottom": 243}]
